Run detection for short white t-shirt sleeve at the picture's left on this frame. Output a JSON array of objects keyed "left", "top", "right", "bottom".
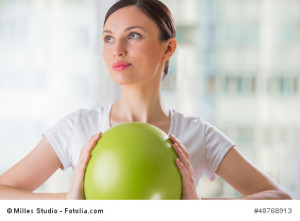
[{"left": 44, "top": 112, "right": 78, "bottom": 170}]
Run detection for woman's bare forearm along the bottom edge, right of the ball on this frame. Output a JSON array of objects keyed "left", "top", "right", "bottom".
[{"left": 201, "top": 190, "right": 292, "bottom": 200}]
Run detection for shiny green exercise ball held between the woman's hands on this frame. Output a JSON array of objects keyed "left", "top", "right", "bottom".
[{"left": 84, "top": 122, "right": 182, "bottom": 200}]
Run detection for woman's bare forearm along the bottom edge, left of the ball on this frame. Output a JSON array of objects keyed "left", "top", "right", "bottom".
[{"left": 0, "top": 185, "right": 66, "bottom": 200}]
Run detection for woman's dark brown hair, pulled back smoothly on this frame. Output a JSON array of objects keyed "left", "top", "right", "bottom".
[{"left": 103, "top": 0, "right": 176, "bottom": 79}]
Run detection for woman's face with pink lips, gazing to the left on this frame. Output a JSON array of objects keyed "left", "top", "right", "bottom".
[{"left": 103, "top": 6, "right": 167, "bottom": 85}]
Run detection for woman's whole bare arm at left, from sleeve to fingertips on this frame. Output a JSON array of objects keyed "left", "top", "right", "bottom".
[{"left": 0, "top": 132, "right": 102, "bottom": 199}]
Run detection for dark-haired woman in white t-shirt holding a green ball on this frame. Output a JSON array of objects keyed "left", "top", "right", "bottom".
[{"left": 0, "top": 0, "right": 290, "bottom": 199}]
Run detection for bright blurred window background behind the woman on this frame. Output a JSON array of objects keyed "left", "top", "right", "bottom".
[{"left": 0, "top": 0, "right": 300, "bottom": 199}]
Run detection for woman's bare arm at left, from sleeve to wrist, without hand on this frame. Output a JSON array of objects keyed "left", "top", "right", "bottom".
[{"left": 0, "top": 137, "right": 65, "bottom": 199}]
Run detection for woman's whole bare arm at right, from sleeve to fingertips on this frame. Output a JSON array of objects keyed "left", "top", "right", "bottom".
[{"left": 170, "top": 135, "right": 291, "bottom": 200}]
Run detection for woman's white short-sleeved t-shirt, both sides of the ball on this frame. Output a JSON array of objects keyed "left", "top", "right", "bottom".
[{"left": 44, "top": 104, "right": 235, "bottom": 183}]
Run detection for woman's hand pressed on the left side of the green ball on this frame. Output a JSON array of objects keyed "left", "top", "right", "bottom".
[{"left": 66, "top": 132, "right": 102, "bottom": 200}]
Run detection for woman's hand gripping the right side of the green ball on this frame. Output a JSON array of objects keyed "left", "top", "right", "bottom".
[{"left": 170, "top": 135, "right": 199, "bottom": 199}]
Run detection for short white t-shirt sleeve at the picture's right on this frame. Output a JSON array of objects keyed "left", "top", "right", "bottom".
[{"left": 204, "top": 122, "right": 236, "bottom": 180}]
